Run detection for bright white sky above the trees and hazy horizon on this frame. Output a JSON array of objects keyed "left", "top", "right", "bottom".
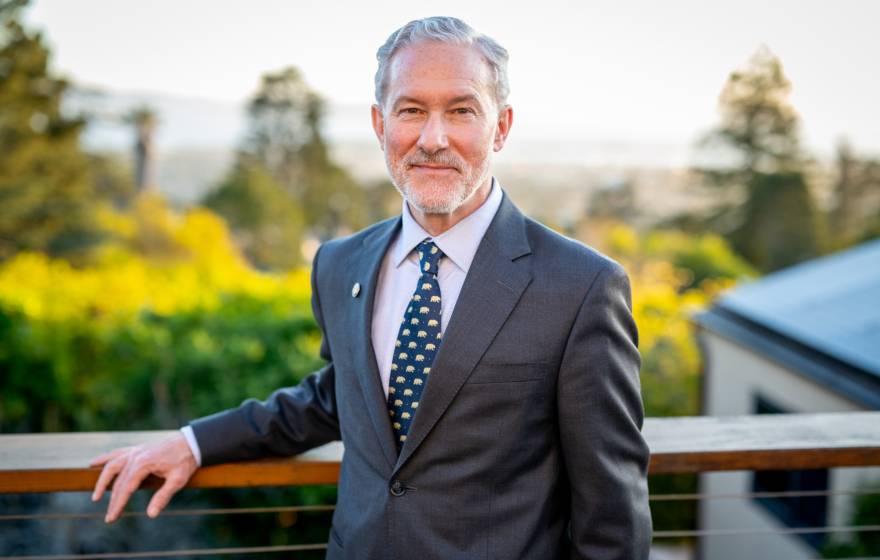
[{"left": 27, "top": 0, "right": 880, "bottom": 163}]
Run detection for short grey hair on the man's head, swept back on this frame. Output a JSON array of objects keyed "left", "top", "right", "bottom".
[{"left": 376, "top": 16, "right": 510, "bottom": 108}]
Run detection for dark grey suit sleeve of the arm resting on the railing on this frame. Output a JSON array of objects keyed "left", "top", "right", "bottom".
[{"left": 190, "top": 243, "right": 340, "bottom": 466}]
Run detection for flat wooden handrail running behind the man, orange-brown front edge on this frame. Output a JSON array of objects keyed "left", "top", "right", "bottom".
[{"left": 0, "top": 412, "right": 880, "bottom": 493}]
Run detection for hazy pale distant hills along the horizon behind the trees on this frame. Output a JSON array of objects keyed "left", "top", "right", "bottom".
[{"left": 65, "top": 87, "right": 704, "bottom": 219}]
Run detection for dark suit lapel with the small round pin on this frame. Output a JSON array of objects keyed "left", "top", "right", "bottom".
[{"left": 347, "top": 217, "right": 400, "bottom": 467}]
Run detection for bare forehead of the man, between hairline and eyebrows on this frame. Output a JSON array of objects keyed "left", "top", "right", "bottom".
[{"left": 386, "top": 42, "right": 492, "bottom": 103}]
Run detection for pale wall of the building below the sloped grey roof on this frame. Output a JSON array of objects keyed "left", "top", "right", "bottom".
[{"left": 699, "top": 331, "right": 880, "bottom": 560}]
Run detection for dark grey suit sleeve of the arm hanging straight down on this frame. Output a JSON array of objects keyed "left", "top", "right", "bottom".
[{"left": 557, "top": 264, "right": 651, "bottom": 560}]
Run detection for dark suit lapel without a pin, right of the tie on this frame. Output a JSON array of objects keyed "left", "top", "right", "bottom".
[{"left": 396, "top": 193, "right": 532, "bottom": 473}]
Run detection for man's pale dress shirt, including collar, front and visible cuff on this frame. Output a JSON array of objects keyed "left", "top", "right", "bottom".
[{"left": 181, "top": 178, "right": 502, "bottom": 465}]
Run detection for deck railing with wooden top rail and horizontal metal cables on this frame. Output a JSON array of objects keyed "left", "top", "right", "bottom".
[{"left": 0, "top": 412, "right": 880, "bottom": 560}]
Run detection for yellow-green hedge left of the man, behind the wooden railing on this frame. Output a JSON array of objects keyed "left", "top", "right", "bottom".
[{"left": 0, "top": 193, "right": 336, "bottom": 558}]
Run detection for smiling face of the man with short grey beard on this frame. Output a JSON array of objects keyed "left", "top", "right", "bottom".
[{"left": 373, "top": 42, "right": 512, "bottom": 221}]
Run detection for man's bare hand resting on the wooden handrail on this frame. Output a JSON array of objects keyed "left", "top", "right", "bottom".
[{"left": 89, "top": 433, "right": 199, "bottom": 523}]
